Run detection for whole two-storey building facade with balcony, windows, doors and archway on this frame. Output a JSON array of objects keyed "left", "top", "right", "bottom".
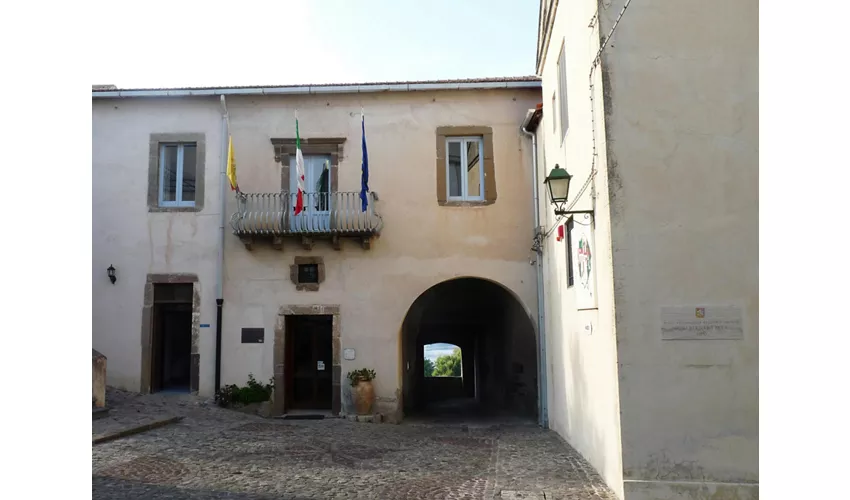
[{"left": 92, "top": 77, "right": 540, "bottom": 418}]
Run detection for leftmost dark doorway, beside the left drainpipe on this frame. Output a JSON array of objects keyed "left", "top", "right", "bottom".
[{"left": 151, "top": 283, "right": 192, "bottom": 392}]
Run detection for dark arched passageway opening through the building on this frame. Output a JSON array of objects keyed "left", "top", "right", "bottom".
[{"left": 402, "top": 278, "right": 538, "bottom": 418}]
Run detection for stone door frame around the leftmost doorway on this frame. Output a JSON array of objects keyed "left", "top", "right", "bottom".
[{"left": 139, "top": 273, "right": 201, "bottom": 394}]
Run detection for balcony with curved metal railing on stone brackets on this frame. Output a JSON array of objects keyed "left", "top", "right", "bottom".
[{"left": 230, "top": 192, "right": 383, "bottom": 250}]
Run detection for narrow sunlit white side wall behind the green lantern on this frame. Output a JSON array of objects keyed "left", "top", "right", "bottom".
[{"left": 538, "top": 0, "right": 623, "bottom": 498}]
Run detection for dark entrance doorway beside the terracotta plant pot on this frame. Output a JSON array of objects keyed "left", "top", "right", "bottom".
[{"left": 284, "top": 315, "right": 333, "bottom": 411}]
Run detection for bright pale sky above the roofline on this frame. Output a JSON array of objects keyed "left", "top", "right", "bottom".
[{"left": 91, "top": 0, "right": 539, "bottom": 88}]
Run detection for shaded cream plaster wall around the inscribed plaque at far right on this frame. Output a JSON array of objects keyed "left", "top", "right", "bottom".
[{"left": 596, "top": 0, "right": 758, "bottom": 500}]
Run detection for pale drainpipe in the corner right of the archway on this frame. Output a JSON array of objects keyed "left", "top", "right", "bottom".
[{"left": 520, "top": 109, "right": 549, "bottom": 429}]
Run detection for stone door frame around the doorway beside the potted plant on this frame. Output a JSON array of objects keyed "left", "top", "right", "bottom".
[{"left": 272, "top": 304, "right": 342, "bottom": 416}]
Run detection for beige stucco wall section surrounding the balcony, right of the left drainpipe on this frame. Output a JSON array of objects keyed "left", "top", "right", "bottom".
[{"left": 222, "top": 90, "right": 540, "bottom": 411}]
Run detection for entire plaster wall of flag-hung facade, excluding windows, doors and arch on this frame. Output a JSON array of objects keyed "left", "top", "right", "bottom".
[{"left": 92, "top": 89, "right": 540, "bottom": 411}]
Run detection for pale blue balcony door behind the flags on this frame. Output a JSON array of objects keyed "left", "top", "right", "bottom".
[{"left": 289, "top": 155, "right": 331, "bottom": 232}]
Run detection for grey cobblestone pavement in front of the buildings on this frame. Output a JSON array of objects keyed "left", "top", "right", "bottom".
[{"left": 92, "top": 396, "right": 615, "bottom": 500}]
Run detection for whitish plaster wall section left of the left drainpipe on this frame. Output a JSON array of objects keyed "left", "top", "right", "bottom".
[{"left": 92, "top": 98, "right": 221, "bottom": 395}]
